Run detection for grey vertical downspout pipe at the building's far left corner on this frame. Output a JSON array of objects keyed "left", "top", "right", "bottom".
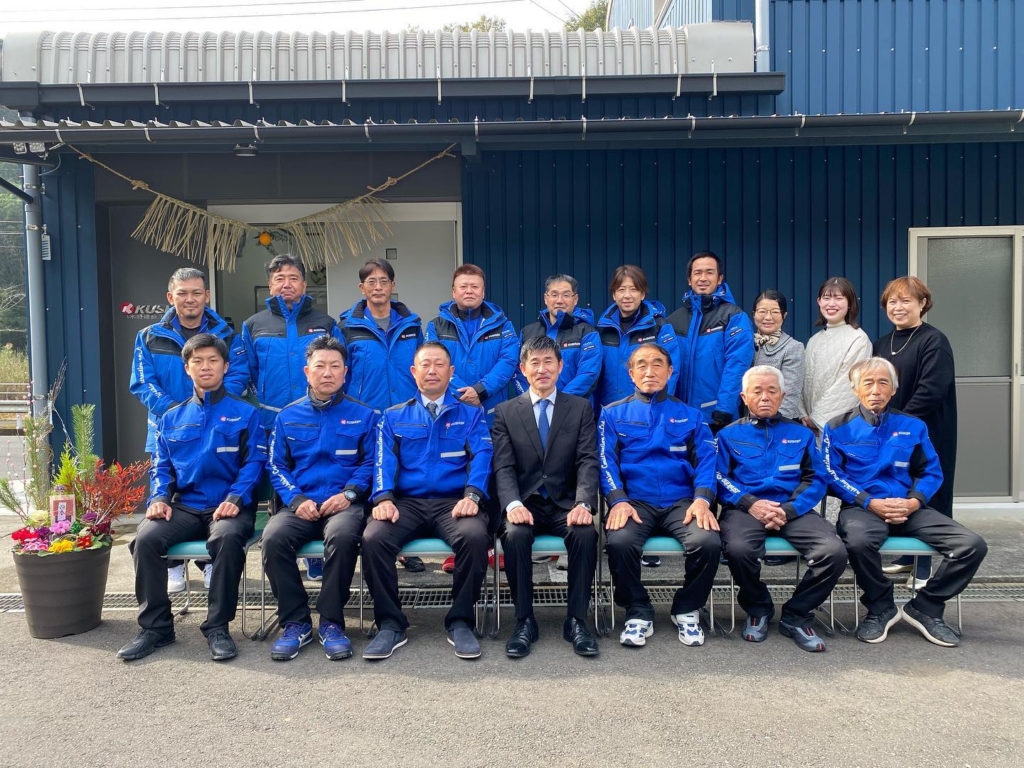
[{"left": 22, "top": 114, "right": 49, "bottom": 416}]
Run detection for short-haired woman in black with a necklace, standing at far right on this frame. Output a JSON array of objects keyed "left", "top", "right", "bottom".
[{"left": 873, "top": 276, "right": 956, "bottom": 588}]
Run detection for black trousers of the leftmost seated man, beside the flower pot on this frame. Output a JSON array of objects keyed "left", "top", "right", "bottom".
[{"left": 129, "top": 504, "right": 256, "bottom": 635}]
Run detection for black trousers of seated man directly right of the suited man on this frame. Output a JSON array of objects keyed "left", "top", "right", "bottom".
[{"left": 605, "top": 499, "right": 722, "bottom": 622}]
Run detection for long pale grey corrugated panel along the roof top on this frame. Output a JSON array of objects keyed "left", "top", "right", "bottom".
[{"left": 0, "top": 24, "right": 754, "bottom": 84}]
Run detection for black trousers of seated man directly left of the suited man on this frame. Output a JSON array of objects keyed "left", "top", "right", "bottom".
[{"left": 362, "top": 499, "right": 490, "bottom": 632}]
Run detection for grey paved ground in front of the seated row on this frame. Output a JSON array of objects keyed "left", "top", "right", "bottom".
[{"left": 0, "top": 603, "right": 1024, "bottom": 768}]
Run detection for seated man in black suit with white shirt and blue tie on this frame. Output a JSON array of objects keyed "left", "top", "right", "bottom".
[{"left": 492, "top": 336, "right": 599, "bottom": 658}]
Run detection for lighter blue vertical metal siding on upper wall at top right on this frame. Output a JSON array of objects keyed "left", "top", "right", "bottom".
[{"left": 774, "top": 0, "right": 1024, "bottom": 115}]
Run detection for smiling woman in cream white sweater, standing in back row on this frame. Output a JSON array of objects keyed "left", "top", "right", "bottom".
[{"left": 802, "top": 278, "right": 871, "bottom": 434}]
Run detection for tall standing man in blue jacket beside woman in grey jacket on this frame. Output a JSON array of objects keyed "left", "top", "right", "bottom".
[{"left": 669, "top": 251, "right": 754, "bottom": 432}]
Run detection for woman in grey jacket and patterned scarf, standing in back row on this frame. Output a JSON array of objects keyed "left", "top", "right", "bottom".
[{"left": 754, "top": 289, "right": 807, "bottom": 421}]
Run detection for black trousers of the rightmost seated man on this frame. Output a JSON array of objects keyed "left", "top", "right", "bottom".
[{"left": 837, "top": 507, "right": 988, "bottom": 618}]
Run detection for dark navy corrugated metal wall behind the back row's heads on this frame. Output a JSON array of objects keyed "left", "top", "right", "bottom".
[{"left": 463, "top": 142, "right": 1024, "bottom": 340}]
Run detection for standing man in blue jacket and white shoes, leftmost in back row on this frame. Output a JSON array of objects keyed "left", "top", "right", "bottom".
[{"left": 129, "top": 266, "right": 249, "bottom": 592}]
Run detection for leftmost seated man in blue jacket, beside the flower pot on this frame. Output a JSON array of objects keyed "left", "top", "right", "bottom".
[{"left": 118, "top": 333, "right": 266, "bottom": 660}]
